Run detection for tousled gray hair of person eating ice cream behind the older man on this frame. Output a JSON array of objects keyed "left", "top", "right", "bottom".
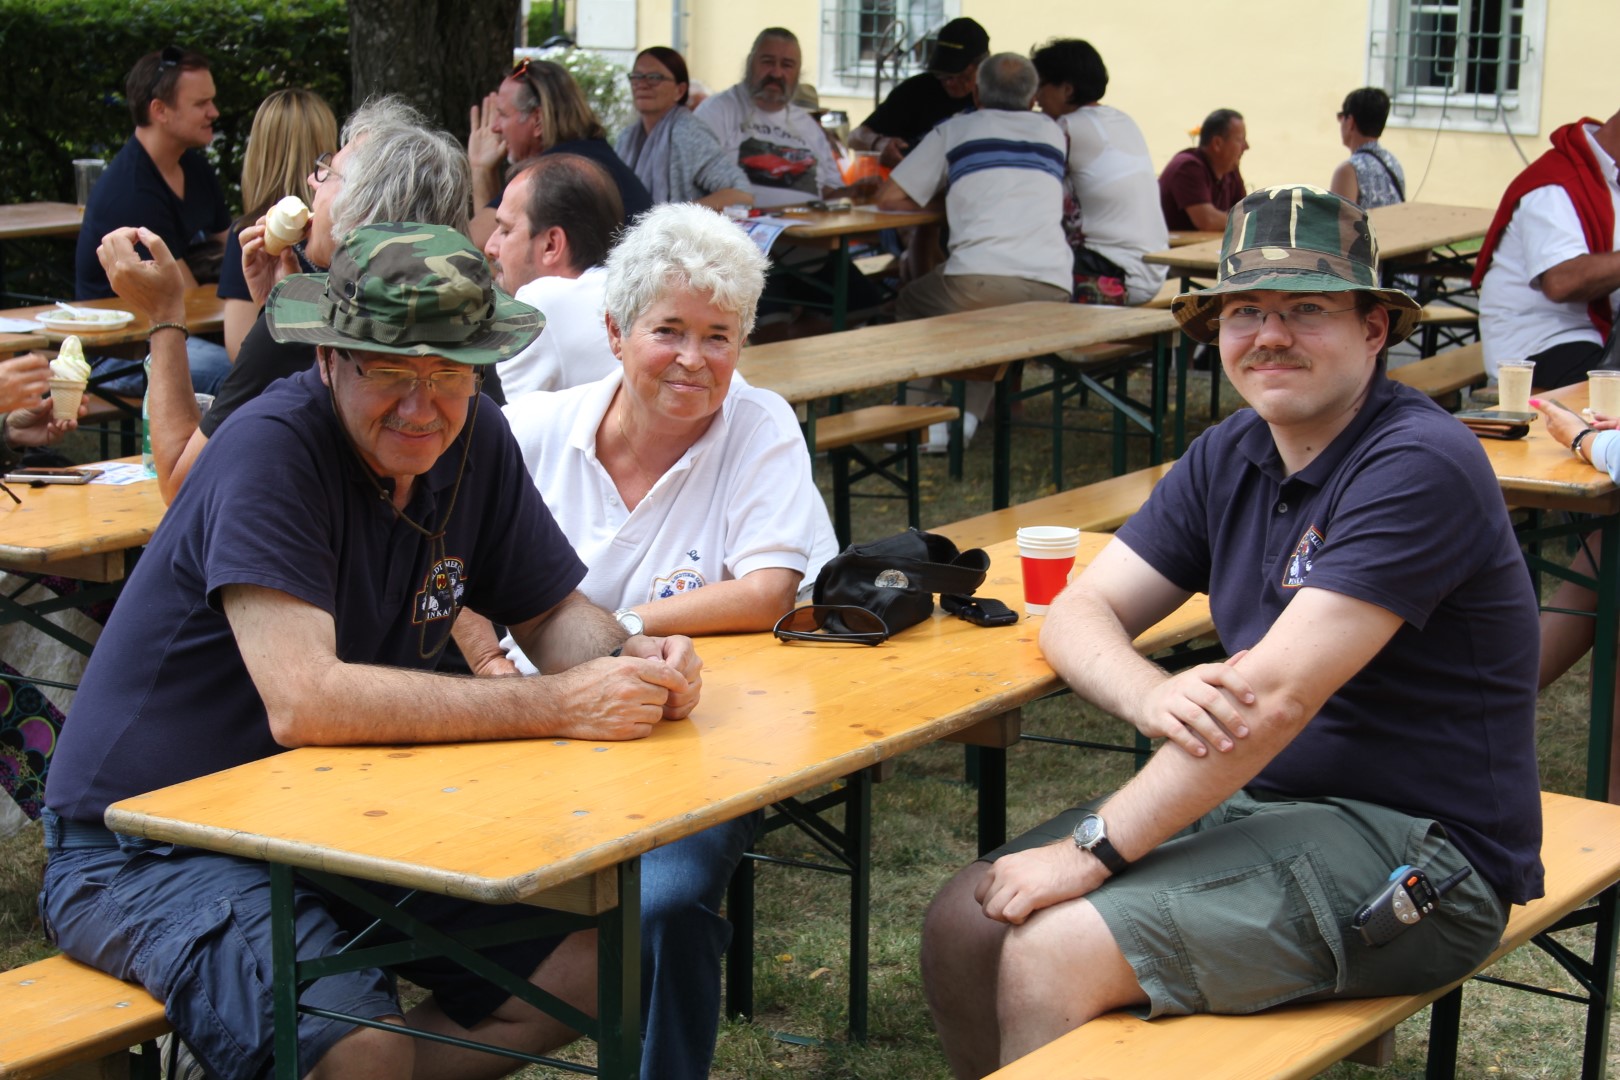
[{"left": 332, "top": 97, "right": 473, "bottom": 244}]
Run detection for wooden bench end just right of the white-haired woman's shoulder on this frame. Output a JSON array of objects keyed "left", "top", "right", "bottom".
[{"left": 805, "top": 405, "right": 961, "bottom": 546}]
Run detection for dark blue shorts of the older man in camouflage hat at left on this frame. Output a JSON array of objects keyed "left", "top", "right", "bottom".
[{"left": 39, "top": 810, "right": 562, "bottom": 1080}]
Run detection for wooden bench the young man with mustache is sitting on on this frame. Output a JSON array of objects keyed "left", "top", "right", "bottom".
[{"left": 991, "top": 793, "right": 1620, "bottom": 1080}]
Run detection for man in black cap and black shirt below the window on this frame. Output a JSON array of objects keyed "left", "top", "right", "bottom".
[{"left": 849, "top": 18, "right": 990, "bottom": 168}]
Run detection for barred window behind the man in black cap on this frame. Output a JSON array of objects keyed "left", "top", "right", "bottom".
[{"left": 818, "top": 0, "right": 959, "bottom": 96}]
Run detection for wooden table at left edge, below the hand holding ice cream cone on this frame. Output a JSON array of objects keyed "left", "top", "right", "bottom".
[{"left": 0, "top": 458, "right": 164, "bottom": 656}]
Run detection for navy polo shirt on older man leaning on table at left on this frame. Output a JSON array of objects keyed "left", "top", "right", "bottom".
[{"left": 45, "top": 362, "right": 585, "bottom": 823}]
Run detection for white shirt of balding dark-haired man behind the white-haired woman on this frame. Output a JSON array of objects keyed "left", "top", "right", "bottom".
[{"left": 499, "top": 266, "right": 619, "bottom": 402}]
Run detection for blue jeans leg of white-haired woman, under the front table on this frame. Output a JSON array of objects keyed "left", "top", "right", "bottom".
[{"left": 642, "top": 811, "right": 765, "bottom": 1080}]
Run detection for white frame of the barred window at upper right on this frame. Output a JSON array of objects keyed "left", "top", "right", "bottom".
[{"left": 1367, "top": 0, "right": 1550, "bottom": 134}]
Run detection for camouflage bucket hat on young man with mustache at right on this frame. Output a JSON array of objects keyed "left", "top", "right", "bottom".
[{"left": 1170, "top": 185, "right": 1421, "bottom": 345}]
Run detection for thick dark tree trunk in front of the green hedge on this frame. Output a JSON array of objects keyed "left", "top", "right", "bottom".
[{"left": 348, "top": 0, "right": 518, "bottom": 142}]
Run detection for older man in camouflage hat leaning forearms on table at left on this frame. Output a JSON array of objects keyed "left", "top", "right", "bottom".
[{"left": 41, "top": 223, "right": 700, "bottom": 1080}]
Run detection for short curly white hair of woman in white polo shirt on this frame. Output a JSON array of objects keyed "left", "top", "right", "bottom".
[{"left": 604, "top": 202, "right": 770, "bottom": 337}]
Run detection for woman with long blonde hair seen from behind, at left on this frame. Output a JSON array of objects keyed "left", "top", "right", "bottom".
[{"left": 219, "top": 89, "right": 339, "bottom": 363}]
